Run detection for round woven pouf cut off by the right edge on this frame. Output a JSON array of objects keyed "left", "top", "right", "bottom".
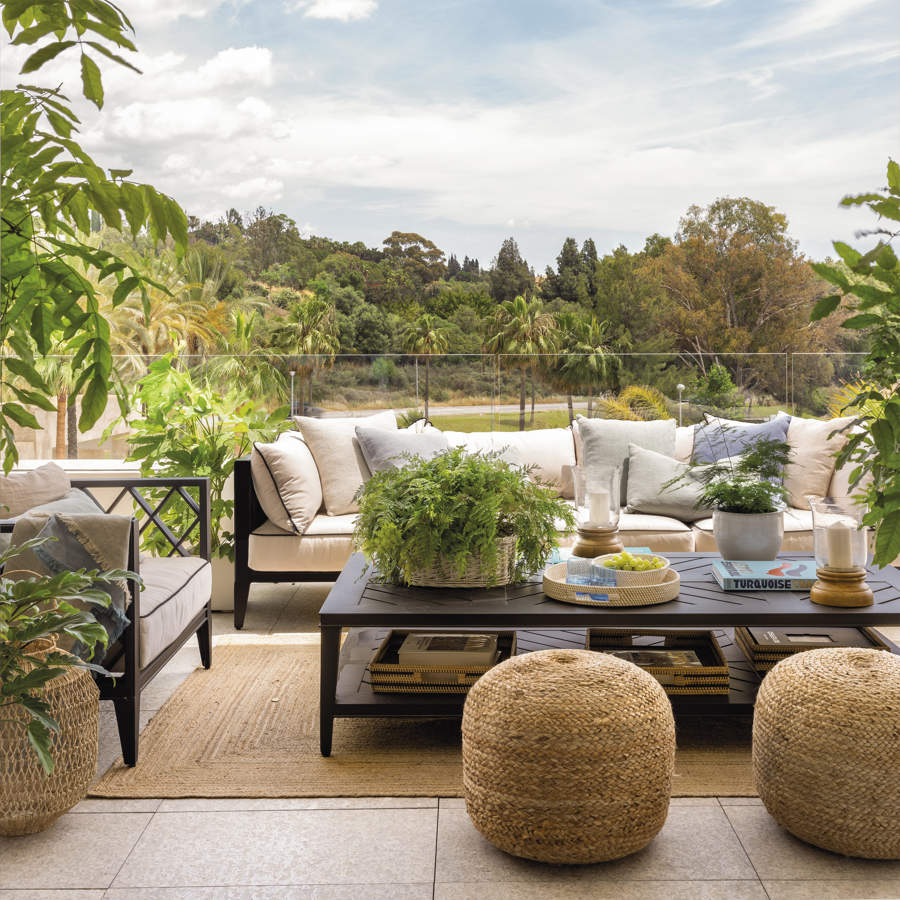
[{"left": 753, "top": 648, "right": 900, "bottom": 859}]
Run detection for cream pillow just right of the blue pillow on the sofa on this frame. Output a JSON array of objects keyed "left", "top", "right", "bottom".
[{"left": 784, "top": 416, "right": 855, "bottom": 509}]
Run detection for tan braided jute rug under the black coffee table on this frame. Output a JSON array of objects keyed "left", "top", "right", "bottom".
[{"left": 91, "top": 635, "right": 756, "bottom": 798}]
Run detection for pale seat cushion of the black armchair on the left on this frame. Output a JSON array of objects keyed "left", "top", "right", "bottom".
[{"left": 140, "top": 556, "right": 212, "bottom": 669}]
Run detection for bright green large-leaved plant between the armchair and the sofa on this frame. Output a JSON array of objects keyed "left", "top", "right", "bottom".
[{"left": 127, "top": 354, "right": 290, "bottom": 560}]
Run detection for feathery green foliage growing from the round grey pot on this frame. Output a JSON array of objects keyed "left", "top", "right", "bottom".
[{"left": 663, "top": 434, "right": 791, "bottom": 513}]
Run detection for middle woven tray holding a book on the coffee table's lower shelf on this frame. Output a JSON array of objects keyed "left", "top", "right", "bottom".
[{"left": 587, "top": 628, "right": 729, "bottom": 697}]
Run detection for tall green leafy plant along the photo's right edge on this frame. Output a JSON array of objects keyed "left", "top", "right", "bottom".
[{"left": 811, "top": 160, "right": 900, "bottom": 566}]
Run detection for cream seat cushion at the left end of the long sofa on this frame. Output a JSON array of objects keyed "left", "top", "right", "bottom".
[{"left": 248, "top": 515, "right": 356, "bottom": 572}]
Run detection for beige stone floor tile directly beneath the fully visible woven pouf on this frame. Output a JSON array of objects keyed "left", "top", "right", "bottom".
[{"left": 436, "top": 806, "right": 756, "bottom": 883}]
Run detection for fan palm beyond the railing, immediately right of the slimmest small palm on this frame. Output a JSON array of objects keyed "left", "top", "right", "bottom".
[{"left": 486, "top": 294, "right": 558, "bottom": 431}]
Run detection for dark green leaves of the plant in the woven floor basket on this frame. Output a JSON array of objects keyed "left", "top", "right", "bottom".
[{"left": 0, "top": 538, "right": 135, "bottom": 775}]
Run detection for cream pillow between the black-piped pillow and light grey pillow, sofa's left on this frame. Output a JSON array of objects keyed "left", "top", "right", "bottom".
[{"left": 294, "top": 413, "right": 397, "bottom": 516}]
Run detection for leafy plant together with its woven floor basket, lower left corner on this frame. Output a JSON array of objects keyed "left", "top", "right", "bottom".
[{"left": 0, "top": 538, "right": 126, "bottom": 836}]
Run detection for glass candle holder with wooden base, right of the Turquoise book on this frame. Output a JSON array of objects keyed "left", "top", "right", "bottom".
[{"left": 808, "top": 497, "right": 874, "bottom": 606}]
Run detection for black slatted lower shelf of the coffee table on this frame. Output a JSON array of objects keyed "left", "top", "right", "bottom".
[{"left": 322, "top": 628, "right": 800, "bottom": 756}]
